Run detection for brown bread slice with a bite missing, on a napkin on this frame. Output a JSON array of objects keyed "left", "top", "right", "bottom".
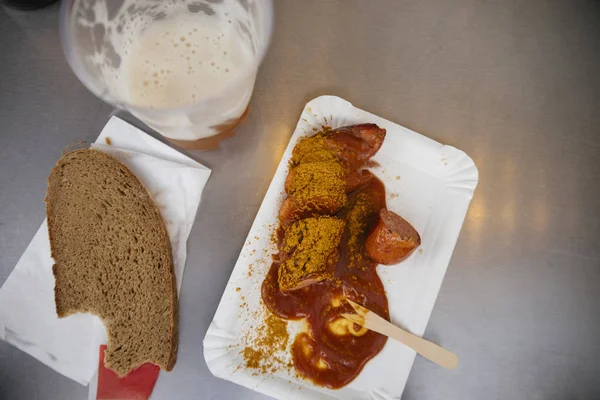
[{"left": 46, "top": 149, "right": 178, "bottom": 376}]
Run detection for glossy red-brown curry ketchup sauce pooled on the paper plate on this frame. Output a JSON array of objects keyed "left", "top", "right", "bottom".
[{"left": 262, "top": 177, "right": 389, "bottom": 389}]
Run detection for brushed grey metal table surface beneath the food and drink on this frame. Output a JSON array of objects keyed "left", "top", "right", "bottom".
[{"left": 0, "top": 0, "right": 600, "bottom": 400}]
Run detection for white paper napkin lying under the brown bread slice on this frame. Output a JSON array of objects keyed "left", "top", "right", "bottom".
[{"left": 0, "top": 117, "right": 210, "bottom": 385}]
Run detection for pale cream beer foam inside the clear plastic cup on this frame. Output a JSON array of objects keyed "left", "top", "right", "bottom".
[{"left": 122, "top": 15, "right": 252, "bottom": 108}]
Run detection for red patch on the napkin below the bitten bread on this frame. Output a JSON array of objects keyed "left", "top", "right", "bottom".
[{"left": 96, "top": 344, "right": 160, "bottom": 400}]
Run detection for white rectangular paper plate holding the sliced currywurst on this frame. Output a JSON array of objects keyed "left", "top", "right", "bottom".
[{"left": 204, "top": 96, "right": 478, "bottom": 400}]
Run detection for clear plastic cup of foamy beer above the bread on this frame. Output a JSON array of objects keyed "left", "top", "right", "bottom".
[{"left": 60, "top": 0, "right": 273, "bottom": 148}]
